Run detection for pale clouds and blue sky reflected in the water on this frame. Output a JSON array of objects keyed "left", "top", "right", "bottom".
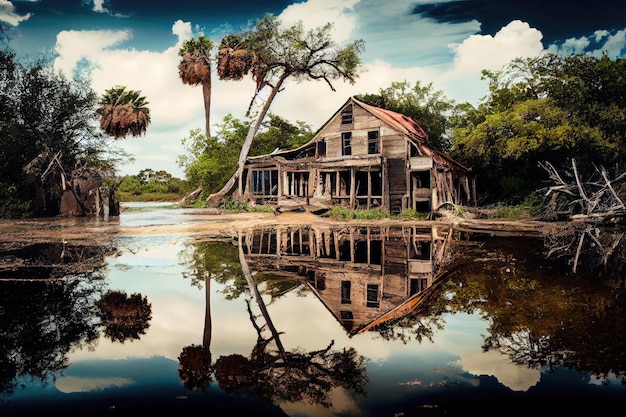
[{"left": 0, "top": 202, "right": 626, "bottom": 416}]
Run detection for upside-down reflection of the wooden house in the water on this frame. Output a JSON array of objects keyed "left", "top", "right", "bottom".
[{"left": 242, "top": 224, "right": 450, "bottom": 334}]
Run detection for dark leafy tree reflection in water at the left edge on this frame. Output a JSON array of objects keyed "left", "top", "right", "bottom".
[{"left": 0, "top": 273, "right": 102, "bottom": 394}]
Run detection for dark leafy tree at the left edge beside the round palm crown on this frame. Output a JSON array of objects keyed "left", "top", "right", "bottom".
[{"left": 0, "top": 51, "right": 119, "bottom": 217}]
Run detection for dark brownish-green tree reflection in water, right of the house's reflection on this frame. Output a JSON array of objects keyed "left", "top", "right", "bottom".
[{"left": 438, "top": 236, "right": 626, "bottom": 381}]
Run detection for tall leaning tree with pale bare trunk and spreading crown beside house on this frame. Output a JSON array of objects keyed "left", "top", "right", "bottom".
[{"left": 207, "top": 14, "right": 364, "bottom": 207}]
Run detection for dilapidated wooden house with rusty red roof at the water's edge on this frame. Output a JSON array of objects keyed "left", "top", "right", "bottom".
[{"left": 238, "top": 97, "right": 476, "bottom": 214}]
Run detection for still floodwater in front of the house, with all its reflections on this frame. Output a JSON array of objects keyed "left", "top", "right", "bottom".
[{"left": 0, "top": 203, "right": 626, "bottom": 417}]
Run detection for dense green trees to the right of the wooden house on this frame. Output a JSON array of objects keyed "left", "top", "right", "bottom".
[{"left": 451, "top": 54, "right": 626, "bottom": 205}]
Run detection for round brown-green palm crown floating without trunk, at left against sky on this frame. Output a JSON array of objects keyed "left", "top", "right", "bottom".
[{"left": 96, "top": 86, "right": 150, "bottom": 139}]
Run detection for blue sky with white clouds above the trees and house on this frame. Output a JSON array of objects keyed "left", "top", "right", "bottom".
[{"left": 0, "top": 0, "right": 626, "bottom": 177}]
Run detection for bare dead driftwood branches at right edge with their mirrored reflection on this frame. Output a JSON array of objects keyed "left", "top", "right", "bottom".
[{"left": 540, "top": 160, "right": 626, "bottom": 272}]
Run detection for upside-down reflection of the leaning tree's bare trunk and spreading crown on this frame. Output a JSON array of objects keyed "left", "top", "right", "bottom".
[{"left": 210, "top": 239, "right": 367, "bottom": 407}]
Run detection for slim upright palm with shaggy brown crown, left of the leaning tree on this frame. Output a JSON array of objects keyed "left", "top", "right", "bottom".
[{"left": 178, "top": 36, "right": 213, "bottom": 138}]
